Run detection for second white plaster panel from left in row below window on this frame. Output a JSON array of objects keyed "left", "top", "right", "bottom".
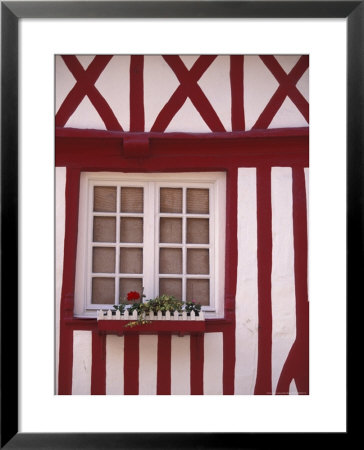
[{"left": 106, "top": 335, "right": 124, "bottom": 395}]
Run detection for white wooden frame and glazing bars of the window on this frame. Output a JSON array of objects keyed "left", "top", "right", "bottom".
[{"left": 74, "top": 172, "right": 226, "bottom": 318}]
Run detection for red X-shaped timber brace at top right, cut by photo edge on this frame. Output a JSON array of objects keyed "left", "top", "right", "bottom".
[{"left": 253, "top": 55, "right": 309, "bottom": 129}]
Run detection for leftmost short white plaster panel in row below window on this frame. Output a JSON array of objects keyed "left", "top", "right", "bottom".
[{"left": 72, "top": 330, "right": 92, "bottom": 395}]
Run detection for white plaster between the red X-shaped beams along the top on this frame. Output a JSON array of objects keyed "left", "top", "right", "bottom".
[{"left": 55, "top": 55, "right": 309, "bottom": 132}]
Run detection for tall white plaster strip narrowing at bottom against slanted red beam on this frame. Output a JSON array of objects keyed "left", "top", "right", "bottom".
[{"left": 271, "top": 167, "right": 296, "bottom": 392}]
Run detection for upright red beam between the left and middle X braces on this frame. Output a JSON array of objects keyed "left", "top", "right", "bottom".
[{"left": 130, "top": 55, "right": 144, "bottom": 132}]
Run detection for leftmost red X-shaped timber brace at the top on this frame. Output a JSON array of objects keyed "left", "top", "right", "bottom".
[{"left": 56, "top": 55, "right": 122, "bottom": 131}]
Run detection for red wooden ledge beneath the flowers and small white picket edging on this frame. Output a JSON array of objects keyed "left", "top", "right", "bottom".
[{"left": 97, "top": 320, "right": 205, "bottom": 336}]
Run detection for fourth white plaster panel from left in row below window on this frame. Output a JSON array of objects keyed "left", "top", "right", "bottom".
[{"left": 171, "top": 336, "right": 191, "bottom": 395}]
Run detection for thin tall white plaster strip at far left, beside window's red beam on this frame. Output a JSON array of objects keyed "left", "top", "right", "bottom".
[{"left": 54, "top": 167, "right": 66, "bottom": 392}]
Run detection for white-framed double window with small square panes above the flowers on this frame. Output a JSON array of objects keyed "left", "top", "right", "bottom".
[{"left": 75, "top": 172, "right": 226, "bottom": 317}]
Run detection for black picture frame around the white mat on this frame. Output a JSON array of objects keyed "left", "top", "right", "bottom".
[{"left": 0, "top": 1, "right": 356, "bottom": 449}]
